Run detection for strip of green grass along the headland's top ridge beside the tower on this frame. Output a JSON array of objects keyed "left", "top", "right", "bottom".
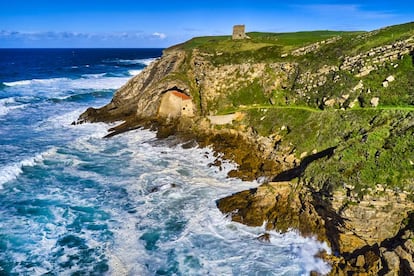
[{"left": 166, "top": 23, "right": 414, "bottom": 62}]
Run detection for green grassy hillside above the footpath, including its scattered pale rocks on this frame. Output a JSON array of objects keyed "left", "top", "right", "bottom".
[{"left": 166, "top": 23, "right": 414, "bottom": 112}]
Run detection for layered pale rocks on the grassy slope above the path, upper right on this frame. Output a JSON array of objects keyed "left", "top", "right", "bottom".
[{"left": 292, "top": 35, "right": 414, "bottom": 108}]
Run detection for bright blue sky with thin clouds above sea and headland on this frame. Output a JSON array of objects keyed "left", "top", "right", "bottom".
[{"left": 0, "top": 0, "right": 414, "bottom": 48}]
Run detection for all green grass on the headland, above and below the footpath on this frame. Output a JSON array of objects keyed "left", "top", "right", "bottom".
[{"left": 166, "top": 23, "right": 414, "bottom": 198}]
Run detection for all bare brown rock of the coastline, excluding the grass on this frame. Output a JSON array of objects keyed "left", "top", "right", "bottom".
[{"left": 74, "top": 23, "right": 414, "bottom": 275}]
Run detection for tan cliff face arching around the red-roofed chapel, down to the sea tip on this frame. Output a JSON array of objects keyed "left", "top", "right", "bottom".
[{"left": 79, "top": 46, "right": 296, "bottom": 122}]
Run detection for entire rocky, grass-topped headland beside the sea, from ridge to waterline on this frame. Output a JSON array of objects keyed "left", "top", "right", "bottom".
[{"left": 76, "top": 23, "right": 414, "bottom": 275}]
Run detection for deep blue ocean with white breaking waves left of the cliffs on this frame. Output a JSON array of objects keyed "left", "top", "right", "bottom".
[{"left": 0, "top": 49, "right": 329, "bottom": 275}]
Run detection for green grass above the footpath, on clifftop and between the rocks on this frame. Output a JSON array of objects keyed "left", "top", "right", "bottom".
[{"left": 175, "top": 23, "right": 414, "bottom": 113}]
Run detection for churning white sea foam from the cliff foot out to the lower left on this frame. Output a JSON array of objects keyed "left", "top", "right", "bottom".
[{"left": 0, "top": 122, "right": 329, "bottom": 275}]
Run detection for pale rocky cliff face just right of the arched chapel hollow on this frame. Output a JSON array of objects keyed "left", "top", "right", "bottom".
[{"left": 191, "top": 50, "right": 297, "bottom": 115}]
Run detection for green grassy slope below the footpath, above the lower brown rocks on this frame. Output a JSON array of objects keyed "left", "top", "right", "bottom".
[{"left": 239, "top": 106, "right": 414, "bottom": 196}]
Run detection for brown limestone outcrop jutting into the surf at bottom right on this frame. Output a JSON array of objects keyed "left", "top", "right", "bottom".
[{"left": 217, "top": 182, "right": 414, "bottom": 275}]
